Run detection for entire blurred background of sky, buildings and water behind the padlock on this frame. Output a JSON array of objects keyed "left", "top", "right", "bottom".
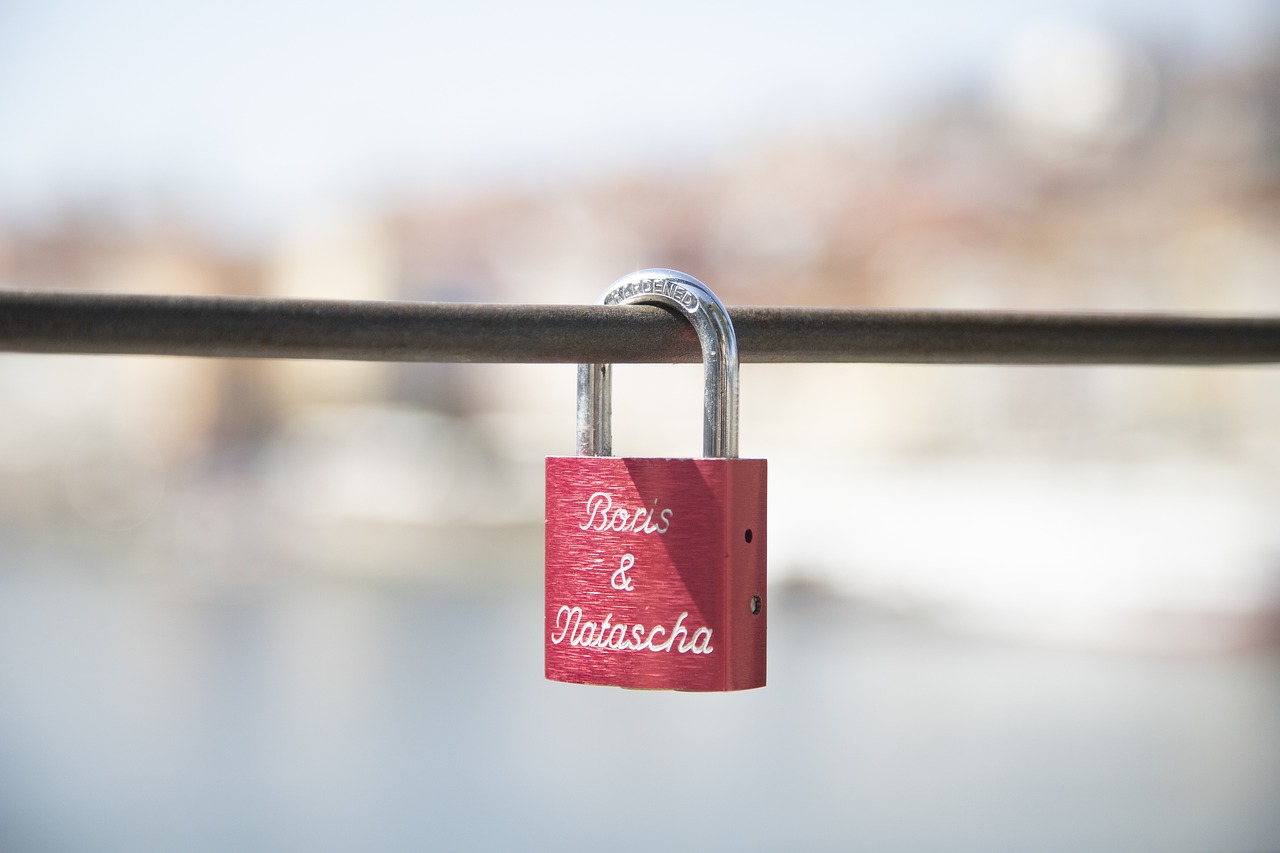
[{"left": 0, "top": 0, "right": 1280, "bottom": 853}]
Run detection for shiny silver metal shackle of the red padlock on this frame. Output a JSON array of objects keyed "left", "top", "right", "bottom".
[{"left": 577, "top": 269, "right": 737, "bottom": 459}]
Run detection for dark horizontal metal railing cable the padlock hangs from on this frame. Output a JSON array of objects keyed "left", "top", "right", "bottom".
[{"left": 0, "top": 289, "right": 1280, "bottom": 365}]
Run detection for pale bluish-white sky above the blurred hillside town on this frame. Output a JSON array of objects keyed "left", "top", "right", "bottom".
[{"left": 0, "top": 0, "right": 1276, "bottom": 236}]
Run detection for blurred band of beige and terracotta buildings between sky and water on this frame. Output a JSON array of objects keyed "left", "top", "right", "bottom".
[{"left": 0, "top": 29, "right": 1280, "bottom": 646}]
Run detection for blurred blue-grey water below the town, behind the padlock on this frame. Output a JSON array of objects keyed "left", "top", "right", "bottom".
[{"left": 0, "top": 540, "right": 1280, "bottom": 852}]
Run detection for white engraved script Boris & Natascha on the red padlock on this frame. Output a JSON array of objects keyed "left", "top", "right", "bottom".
[{"left": 549, "top": 492, "right": 716, "bottom": 654}]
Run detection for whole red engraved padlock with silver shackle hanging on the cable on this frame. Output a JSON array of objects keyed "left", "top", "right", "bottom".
[{"left": 545, "top": 269, "right": 768, "bottom": 692}]
